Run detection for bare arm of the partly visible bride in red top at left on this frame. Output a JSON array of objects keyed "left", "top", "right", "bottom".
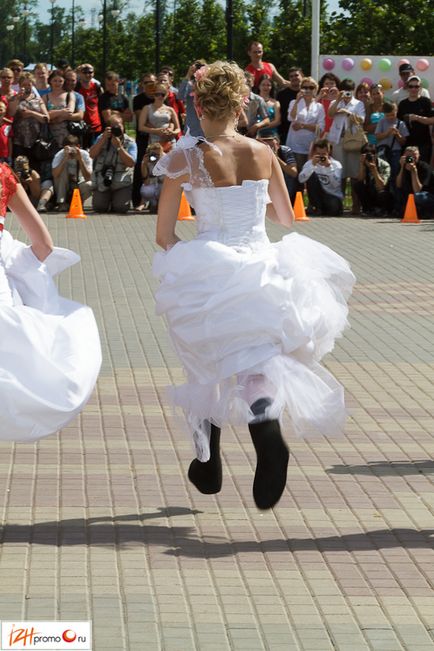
[{"left": 8, "top": 184, "right": 53, "bottom": 261}]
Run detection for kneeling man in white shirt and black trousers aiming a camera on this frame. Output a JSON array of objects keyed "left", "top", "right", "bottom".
[{"left": 298, "top": 138, "right": 343, "bottom": 216}]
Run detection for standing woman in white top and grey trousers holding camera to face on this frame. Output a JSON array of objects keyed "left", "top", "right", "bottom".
[{"left": 328, "top": 79, "right": 366, "bottom": 214}]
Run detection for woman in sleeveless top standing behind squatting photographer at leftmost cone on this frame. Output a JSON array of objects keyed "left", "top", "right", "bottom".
[{"left": 44, "top": 70, "right": 75, "bottom": 149}]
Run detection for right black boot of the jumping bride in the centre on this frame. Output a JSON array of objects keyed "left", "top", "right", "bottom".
[{"left": 249, "top": 401, "right": 289, "bottom": 510}]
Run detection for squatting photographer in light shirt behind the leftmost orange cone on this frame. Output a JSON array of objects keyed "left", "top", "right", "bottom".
[{"left": 52, "top": 135, "right": 92, "bottom": 211}]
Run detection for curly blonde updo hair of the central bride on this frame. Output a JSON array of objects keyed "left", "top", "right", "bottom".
[{"left": 195, "top": 61, "right": 249, "bottom": 120}]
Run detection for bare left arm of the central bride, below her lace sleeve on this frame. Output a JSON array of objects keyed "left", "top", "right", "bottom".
[{"left": 156, "top": 175, "right": 187, "bottom": 250}]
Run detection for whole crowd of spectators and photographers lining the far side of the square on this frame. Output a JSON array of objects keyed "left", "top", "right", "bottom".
[{"left": 0, "top": 51, "right": 434, "bottom": 217}]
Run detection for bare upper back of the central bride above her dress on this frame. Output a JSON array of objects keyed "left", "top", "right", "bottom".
[{"left": 200, "top": 136, "right": 272, "bottom": 187}]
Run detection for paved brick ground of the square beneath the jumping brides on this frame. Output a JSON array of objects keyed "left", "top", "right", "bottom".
[{"left": 0, "top": 215, "right": 434, "bottom": 651}]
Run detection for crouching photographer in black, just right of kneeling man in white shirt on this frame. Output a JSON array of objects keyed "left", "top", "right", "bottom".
[{"left": 354, "top": 144, "right": 393, "bottom": 216}]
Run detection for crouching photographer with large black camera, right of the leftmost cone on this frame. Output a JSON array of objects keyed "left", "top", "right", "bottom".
[{"left": 89, "top": 111, "right": 137, "bottom": 213}]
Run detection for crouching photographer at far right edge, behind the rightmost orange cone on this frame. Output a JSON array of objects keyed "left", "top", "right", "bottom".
[{"left": 396, "top": 146, "right": 434, "bottom": 217}]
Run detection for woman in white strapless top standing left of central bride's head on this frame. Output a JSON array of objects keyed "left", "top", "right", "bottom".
[{"left": 139, "top": 84, "right": 181, "bottom": 152}]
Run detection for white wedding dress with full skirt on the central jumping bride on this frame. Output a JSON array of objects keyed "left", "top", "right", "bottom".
[{"left": 153, "top": 136, "right": 355, "bottom": 461}]
